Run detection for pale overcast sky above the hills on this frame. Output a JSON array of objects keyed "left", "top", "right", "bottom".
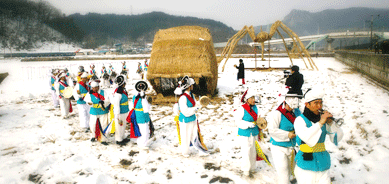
[{"left": 47, "top": 0, "right": 389, "bottom": 30}]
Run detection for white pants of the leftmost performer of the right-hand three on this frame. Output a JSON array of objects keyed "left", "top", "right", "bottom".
[{"left": 239, "top": 136, "right": 258, "bottom": 172}]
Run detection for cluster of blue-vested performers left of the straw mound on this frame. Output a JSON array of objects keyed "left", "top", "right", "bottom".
[{"left": 50, "top": 62, "right": 154, "bottom": 149}]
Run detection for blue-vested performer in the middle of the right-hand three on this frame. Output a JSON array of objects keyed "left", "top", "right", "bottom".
[{"left": 266, "top": 94, "right": 301, "bottom": 184}]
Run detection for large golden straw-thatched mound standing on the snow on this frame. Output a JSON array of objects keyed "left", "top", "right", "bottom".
[{"left": 147, "top": 26, "right": 218, "bottom": 96}]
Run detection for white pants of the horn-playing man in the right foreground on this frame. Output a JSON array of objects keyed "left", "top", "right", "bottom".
[{"left": 294, "top": 165, "right": 331, "bottom": 184}]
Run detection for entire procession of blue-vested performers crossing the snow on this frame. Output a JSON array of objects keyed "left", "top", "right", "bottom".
[{"left": 52, "top": 64, "right": 343, "bottom": 183}]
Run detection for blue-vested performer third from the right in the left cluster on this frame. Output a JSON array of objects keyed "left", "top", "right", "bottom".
[{"left": 84, "top": 81, "right": 110, "bottom": 145}]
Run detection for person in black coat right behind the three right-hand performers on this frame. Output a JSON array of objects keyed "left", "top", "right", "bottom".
[{"left": 285, "top": 65, "right": 304, "bottom": 95}]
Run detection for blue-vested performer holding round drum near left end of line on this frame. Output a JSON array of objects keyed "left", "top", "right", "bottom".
[{"left": 56, "top": 73, "right": 73, "bottom": 119}]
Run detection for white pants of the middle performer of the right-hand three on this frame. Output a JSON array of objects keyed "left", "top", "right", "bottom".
[{"left": 271, "top": 145, "right": 293, "bottom": 184}]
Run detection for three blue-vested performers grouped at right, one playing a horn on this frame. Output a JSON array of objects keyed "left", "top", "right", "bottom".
[{"left": 235, "top": 87, "right": 343, "bottom": 184}]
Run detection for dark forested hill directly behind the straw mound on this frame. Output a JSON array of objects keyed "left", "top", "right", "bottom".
[{"left": 69, "top": 12, "right": 235, "bottom": 45}]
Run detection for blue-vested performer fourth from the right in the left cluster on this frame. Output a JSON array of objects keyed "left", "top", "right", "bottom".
[{"left": 73, "top": 72, "right": 90, "bottom": 131}]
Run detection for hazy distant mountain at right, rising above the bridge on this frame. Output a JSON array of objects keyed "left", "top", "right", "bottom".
[{"left": 255, "top": 8, "right": 389, "bottom": 36}]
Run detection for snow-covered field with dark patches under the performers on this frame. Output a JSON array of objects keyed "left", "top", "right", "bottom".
[{"left": 0, "top": 58, "right": 389, "bottom": 184}]
